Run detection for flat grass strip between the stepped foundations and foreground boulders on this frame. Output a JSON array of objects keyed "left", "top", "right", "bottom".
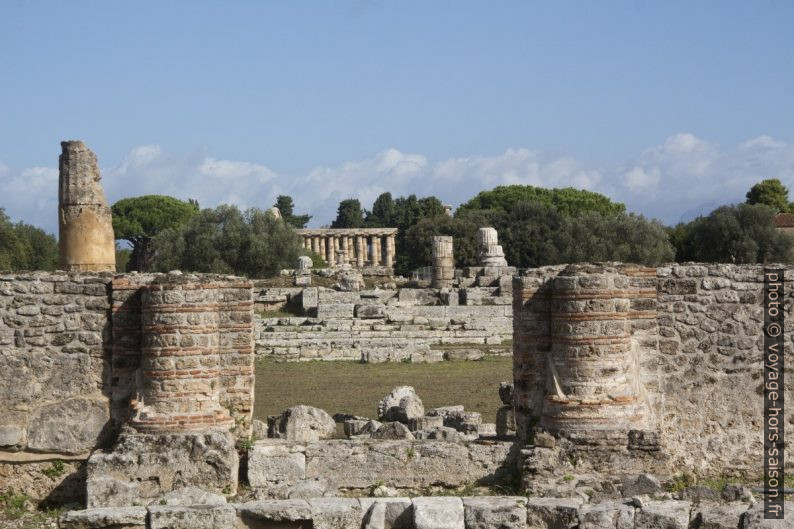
[{"left": 254, "top": 356, "right": 513, "bottom": 422}]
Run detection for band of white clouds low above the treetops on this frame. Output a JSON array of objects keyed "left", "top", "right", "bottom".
[{"left": 0, "top": 133, "right": 794, "bottom": 231}]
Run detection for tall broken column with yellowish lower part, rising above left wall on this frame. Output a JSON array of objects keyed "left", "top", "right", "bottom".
[{"left": 58, "top": 141, "right": 116, "bottom": 271}]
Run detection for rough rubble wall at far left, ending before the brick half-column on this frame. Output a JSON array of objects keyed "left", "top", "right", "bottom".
[{"left": 0, "top": 272, "right": 112, "bottom": 461}]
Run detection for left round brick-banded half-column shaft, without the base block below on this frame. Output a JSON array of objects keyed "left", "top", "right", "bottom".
[{"left": 131, "top": 275, "right": 234, "bottom": 432}]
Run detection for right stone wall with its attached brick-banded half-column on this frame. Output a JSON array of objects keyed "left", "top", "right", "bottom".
[{"left": 514, "top": 264, "right": 794, "bottom": 476}]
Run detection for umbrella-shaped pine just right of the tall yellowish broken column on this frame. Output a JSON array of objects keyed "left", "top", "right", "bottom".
[{"left": 111, "top": 195, "right": 199, "bottom": 271}]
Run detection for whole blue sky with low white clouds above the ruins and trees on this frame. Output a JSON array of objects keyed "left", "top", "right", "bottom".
[{"left": 0, "top": 0, "right": 794, "bottom": 233}]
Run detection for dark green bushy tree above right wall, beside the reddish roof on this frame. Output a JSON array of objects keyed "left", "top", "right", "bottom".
[{"left": 676, "top": 204, "right": 794, "bottom": 264}]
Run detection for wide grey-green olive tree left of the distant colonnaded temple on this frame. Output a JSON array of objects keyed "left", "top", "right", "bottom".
[{"left": 152, "top": 205, "right": 306, "bottom": 277}]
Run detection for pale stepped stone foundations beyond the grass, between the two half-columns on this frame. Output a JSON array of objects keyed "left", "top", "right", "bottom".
[{"left": 256, "top": 269, "right": 513, "bottom": 362}]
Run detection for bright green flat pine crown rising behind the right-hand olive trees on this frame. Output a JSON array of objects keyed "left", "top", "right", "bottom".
[{"left": 455, "top": 185, "right": 626, "bottom": 217}]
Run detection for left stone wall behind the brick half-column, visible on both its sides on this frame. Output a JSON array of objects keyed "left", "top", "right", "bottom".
[{"left": 0, "top": 272, "right": 254, "bottom": 462}]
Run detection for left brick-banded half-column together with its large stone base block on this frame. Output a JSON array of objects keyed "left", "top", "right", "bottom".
[{"left": 87, "top": 274, "right": 246, "bottom": 507}]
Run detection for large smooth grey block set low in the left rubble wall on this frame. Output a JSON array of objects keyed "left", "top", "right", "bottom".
[{"left": 28, "top": 398, "right": 110, "bottom": 454}]
